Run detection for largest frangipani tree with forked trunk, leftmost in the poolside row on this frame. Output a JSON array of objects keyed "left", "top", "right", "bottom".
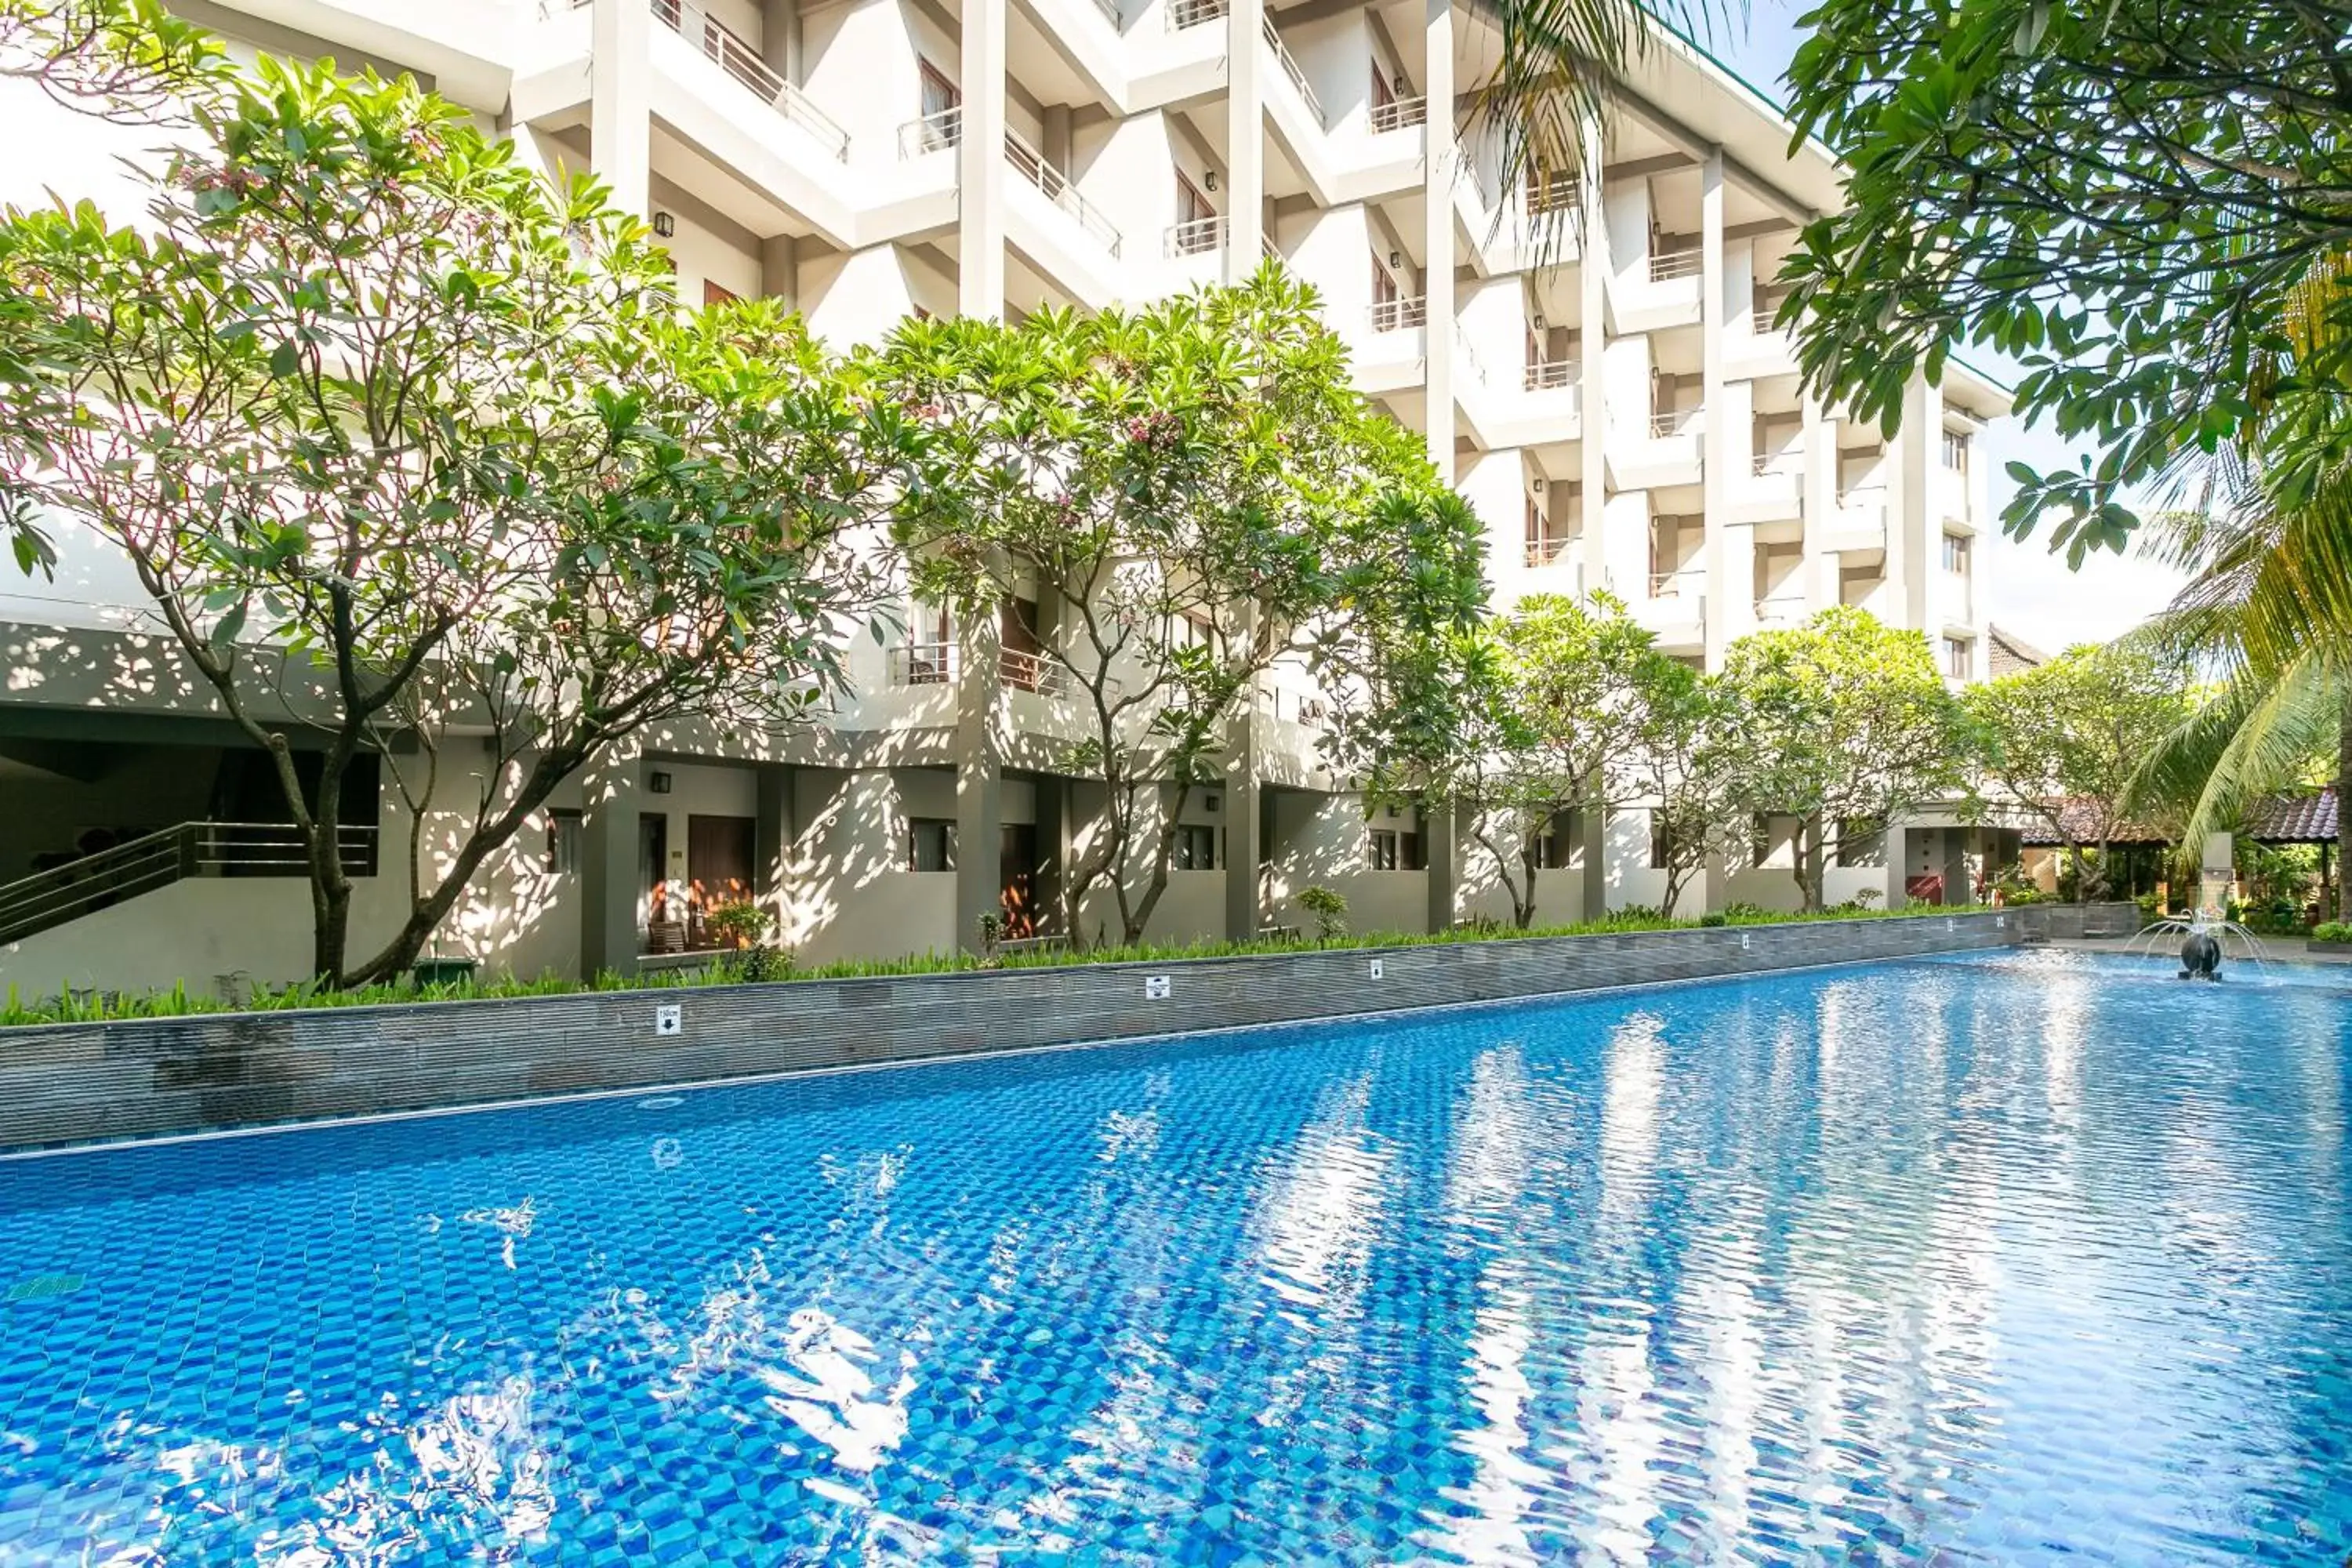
[{"left": 0, "top": 59, "right": 913, "bottom": 985}]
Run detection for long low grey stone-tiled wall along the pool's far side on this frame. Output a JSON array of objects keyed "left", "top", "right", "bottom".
[{"left": 0, "top": 909, "right": 2039, "bottom": 1149}]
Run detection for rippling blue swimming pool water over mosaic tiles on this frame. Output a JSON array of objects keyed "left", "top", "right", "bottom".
[{"left": 0, "top": 954, "right": 2352, "bottom": 1568}]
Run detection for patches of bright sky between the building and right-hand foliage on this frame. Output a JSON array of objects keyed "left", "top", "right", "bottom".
[{"left": 1693, "top": 0, "right": 2180, "bottom": 654}]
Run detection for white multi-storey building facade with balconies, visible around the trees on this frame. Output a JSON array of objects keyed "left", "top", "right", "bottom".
[{"left": 0, "top": 0, "right": 2006, "bottom": 992}]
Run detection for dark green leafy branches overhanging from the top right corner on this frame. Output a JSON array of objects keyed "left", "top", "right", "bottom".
[{"left": 1783, "top": 0, "right": 2352, "bottom": 564}]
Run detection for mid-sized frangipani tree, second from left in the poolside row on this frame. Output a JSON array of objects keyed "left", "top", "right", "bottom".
[{"left": 863, "top": 266, "right": 1479, "bottom": 942}]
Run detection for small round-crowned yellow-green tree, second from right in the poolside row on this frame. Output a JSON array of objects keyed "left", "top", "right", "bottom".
[{"left": 1722, "top": 607, "right": 1964, "bottom": 909}]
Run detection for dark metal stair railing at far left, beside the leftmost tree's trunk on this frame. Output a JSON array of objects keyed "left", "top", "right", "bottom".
[{"left": 0, "top": 822, "right": 376, "bottom": 945}]
